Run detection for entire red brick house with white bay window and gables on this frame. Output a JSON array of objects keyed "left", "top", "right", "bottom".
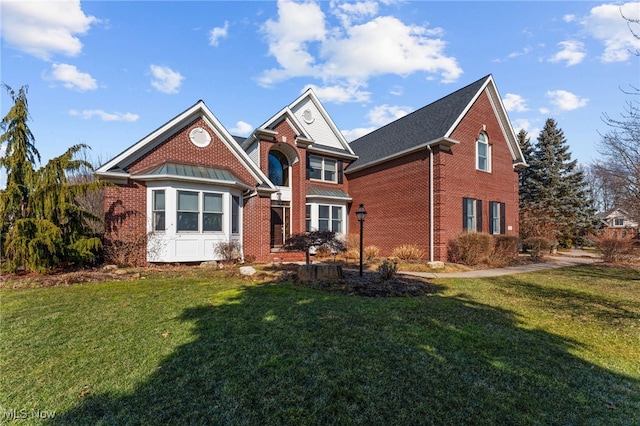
[{"left": 96, "top": 76, "right": 525, "bottom": 263}]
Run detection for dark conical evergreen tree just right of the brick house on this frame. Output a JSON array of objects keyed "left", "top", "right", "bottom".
[{"left": 520, "top": 118, "right": 595, "bottom": 246}]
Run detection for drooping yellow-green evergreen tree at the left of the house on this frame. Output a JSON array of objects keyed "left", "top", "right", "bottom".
[{"left": 0, "top": 85, "right": 104, "bottom": 272}]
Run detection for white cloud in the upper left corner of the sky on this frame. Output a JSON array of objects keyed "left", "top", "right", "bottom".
[{"left": 1, "top": 0, "right": 98, "bottom": 61}]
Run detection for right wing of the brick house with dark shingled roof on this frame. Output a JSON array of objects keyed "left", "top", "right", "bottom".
[{"left": 346, "top": 75, "right": 526, "bottom": 261}]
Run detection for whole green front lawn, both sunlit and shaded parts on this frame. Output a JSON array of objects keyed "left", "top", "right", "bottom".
[{"left": 0, "top": 266, "right": 640, "bottom": 425}]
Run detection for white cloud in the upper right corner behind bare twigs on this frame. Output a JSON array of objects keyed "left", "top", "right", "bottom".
[{"left": 582, "top": 2, "right": 640, "bottom": 62}]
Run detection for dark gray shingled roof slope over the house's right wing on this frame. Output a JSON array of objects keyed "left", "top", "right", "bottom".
[{"left": 347, "top": 75, "right": 490, "bottom": 171}]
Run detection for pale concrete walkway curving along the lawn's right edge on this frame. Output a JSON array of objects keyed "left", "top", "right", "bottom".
[{"left": 398, "top": 249, "right": 600, "bottom": 278}]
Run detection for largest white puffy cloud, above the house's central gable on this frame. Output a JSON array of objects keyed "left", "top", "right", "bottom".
[{"left": 259, "top": 0, "right": 462, "bottom": 97}]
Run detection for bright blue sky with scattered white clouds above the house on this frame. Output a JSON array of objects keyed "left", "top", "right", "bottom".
[{"left": 0, "top": 0, "right": 640, "bottom": 186}]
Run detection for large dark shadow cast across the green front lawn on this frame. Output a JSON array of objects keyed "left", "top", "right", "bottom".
[{"left": 53, "top": 284, "right": 640, "bottom": 425}]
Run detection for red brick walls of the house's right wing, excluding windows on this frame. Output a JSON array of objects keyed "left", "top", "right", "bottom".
[{"left": 348, "top": 89, "right": 519, "bottom": 260}]
